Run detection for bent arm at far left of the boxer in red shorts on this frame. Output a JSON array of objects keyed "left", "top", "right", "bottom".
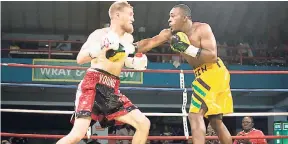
[{"left": 77, "top": 30, "right": 102, "bottom": 65}]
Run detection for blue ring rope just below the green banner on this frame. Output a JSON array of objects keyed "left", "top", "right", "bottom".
[{"left": 1, "top": 83, "right": 288, "bottom": 92}]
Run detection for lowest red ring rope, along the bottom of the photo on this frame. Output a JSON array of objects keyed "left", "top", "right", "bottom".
[{"left": 1, "top": 132, "right": 288, "bottom": 140}]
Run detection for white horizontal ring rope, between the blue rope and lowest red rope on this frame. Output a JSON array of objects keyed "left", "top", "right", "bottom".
[{"left": 0, "top": 109, "right": 288, "bottom": 117}]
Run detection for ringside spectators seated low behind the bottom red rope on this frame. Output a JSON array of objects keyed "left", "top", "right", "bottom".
[{"left": 112, "top": 117, "right": 267, "bottom": 144}]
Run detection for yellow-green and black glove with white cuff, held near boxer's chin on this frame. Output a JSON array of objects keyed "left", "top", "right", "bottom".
[{"left": 170, "top": 32, "right": 201, "bottom": 57}]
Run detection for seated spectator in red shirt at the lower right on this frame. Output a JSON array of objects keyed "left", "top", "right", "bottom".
[{"left": 233, "top": 116, "right": 267, "bottom": 144}]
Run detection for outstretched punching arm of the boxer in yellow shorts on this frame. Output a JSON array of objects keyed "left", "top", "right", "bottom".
[{"left": 135, "top": 29, "right": 172, "bottom": 53}]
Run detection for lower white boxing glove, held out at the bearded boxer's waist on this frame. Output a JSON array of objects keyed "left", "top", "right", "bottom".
[{"left": 125, "top": 53, "right": 148, "bottom": 70}]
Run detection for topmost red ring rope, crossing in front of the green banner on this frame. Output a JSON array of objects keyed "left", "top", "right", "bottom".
[{"left": 1, "top": 63, "right": 288, "bottom": 74}]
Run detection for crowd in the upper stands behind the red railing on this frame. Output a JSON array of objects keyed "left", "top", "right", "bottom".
[{"left": 1, "top": 35, "right": 288, "bottom": 67}]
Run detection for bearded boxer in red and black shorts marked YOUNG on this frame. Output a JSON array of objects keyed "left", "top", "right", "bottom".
[{"left": 57, "top": 1, "right": 150, "bottom": 144}]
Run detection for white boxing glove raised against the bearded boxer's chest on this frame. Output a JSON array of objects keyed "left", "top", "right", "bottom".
[{"left": 101, "top": 31, "right": 120, "bottom": 50}]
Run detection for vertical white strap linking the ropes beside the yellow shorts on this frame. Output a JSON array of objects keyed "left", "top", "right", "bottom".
[{"left": 180, "top": 70, "right": 189, "bottom": 139}]
